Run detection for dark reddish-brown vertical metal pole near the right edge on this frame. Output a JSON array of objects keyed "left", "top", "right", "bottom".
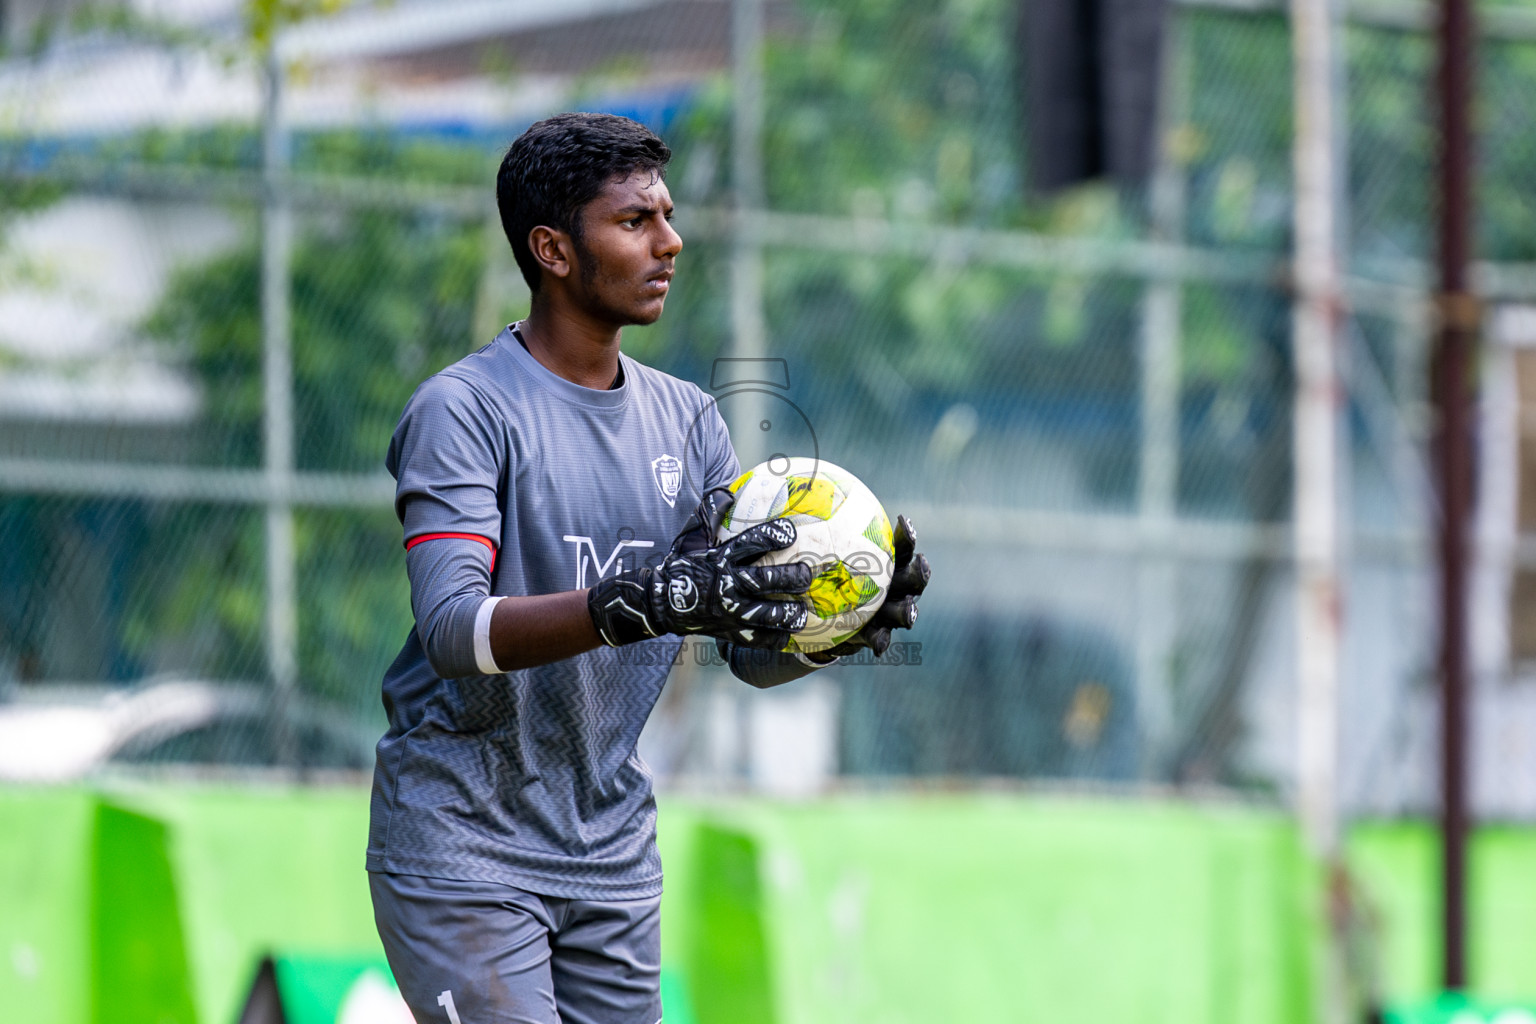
[{"left": 1433, "top": 0, "right": 1479, "bottom": 990}]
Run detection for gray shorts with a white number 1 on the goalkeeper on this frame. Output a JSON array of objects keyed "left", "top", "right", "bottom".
[{"left": 369, "top": 872, "right": 662, "bottom": 1024}]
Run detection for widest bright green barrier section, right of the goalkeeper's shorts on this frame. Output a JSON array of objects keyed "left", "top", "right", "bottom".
[{"left": 691, "top": 795, "right": 1321, "bottom": 1024}]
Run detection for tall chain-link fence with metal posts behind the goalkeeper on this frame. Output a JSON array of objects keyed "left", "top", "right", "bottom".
[{"left": 0, "top": 0, "right": 1536, "bottom": 814}]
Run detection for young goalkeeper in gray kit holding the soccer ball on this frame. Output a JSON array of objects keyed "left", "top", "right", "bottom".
[{"left": 367, "top": 114, "right": 928, "bottom": 1024}]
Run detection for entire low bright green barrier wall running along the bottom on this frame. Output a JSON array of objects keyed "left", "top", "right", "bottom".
[{"left": 21, "top": 786, "right": 1486, "bottom": 1024}]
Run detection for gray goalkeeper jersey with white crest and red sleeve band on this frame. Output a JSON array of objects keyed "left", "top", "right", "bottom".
[{"left": 367, "top": 330, "right": 806, "bottom": 900}]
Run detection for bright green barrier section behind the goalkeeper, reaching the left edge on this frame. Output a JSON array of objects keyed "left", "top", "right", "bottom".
[{"left": 0, "top": 785, "right": 697, "bottom": 1024}]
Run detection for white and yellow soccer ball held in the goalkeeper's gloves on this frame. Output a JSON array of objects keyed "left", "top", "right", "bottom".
[{"left": 716, "top": 456, "right": 895, "bottom": 651}]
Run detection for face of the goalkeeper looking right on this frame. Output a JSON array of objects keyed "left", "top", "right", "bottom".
[{"left": 571, "top": 170, "right": 682, "bottom": 327}]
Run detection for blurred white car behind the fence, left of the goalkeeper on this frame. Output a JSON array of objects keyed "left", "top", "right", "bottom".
[{"left": 0, "top": 680, "right": 378, "bottom": 781}]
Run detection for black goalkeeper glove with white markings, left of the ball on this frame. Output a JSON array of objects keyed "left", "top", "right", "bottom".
[{"left": 587, "top": 487, "right": 814, "bottom": 649}]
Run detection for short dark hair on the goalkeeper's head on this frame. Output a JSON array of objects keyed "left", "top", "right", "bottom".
[{"left": 496, "top": 114, "right": 671, "bottom": 292}]
